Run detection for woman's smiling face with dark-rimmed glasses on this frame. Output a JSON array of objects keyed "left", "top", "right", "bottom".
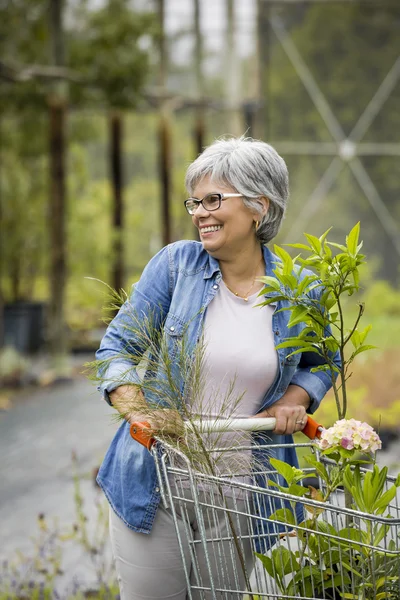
[{"left": 192, "top": 177, "right": 258, "bottom": 260}]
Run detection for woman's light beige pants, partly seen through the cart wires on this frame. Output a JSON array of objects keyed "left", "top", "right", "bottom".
[{"left": 110, "top": 488, "right": 254, "bottom": 600}]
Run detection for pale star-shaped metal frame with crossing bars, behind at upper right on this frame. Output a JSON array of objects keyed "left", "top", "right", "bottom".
[{"left": 262, "top": 7, "right": 400, "bottom": 256}]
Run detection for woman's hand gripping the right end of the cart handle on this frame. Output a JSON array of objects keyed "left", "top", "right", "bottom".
[{"left": 255, "top": 385, "right": 310, "bottom": 434}]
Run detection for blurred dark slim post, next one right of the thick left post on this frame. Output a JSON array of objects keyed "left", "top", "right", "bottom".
[{"left": 110, "top": 112, "right": 125, "bottom": 291}]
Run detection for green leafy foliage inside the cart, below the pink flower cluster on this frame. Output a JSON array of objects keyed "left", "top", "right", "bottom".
[{"left": 256, "top": 446, "right": 400, "bottom": 600}]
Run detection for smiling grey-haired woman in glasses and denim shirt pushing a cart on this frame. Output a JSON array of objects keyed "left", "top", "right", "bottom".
[{"left": 97, "top": 137, "right": 338, "bottom": 600}]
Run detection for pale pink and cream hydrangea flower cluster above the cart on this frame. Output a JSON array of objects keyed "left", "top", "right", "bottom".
[{"left": 319, "top": 419, "right": 382, "bottom": 452}]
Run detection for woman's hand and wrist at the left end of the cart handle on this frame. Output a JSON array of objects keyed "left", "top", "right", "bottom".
[{"left": 110, "top": 385, "right": 184, "bottom": 437}]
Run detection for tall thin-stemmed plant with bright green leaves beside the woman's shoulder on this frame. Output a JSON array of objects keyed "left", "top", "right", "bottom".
[{"left": 260, "top": 223, "right": 374, "bottom": 419}]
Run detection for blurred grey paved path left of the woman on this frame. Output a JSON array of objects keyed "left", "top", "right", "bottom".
[{"left": 0, "top": 378, "right": 117, "bottom": 592}]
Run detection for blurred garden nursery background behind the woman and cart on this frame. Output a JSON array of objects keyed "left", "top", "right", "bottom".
[{"left": 0, "top": 0, "right": 400, "bottom": 598}]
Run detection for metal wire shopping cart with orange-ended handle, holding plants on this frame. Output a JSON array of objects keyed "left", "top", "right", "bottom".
[{"left": 131, "top": 418, "right": 400, "bottom": 600}]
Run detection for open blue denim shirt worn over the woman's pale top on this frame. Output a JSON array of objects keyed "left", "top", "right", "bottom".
[{"left": 96, "top": 241, "right": 340, "bottom": 550}]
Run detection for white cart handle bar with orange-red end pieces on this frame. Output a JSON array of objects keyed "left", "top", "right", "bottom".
[{"left": 130, "top": 417, "right": 323, "bottom": 450}]
